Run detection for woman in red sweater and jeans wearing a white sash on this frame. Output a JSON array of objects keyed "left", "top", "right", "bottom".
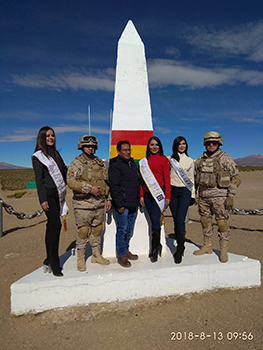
[{"left": 140, "top": 136, "right": 171, "bottom": 262}]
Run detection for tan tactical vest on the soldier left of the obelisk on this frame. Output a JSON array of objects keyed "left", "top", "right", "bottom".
[{"left": 75, "top": 155, "right": 109, "bottom": 197}]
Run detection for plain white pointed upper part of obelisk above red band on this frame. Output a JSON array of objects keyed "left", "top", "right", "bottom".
[{"left": 112, "top": 21, "right": 153, "bottom": 130}]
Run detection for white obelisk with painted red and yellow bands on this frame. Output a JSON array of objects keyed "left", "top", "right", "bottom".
[{"left": 103, "top": 21, "right": 159, "bottom": 257}]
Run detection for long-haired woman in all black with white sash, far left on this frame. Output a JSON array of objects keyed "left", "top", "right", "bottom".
[{"left": 32, "top": 126, "right": 67, "bottom": 276}]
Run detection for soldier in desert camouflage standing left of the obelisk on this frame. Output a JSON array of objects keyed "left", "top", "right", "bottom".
[{"left": 67, "top": 135, "right": 111, "bottom": 271}]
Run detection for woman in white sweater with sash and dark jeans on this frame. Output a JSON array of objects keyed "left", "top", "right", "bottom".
[{"left": 168, "top": 136, "right": 195, "bottom": 264}]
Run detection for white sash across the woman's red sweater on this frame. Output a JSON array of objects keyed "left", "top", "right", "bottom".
[{"left": 139, "top": 158, "right": 165, "bottom": 212}]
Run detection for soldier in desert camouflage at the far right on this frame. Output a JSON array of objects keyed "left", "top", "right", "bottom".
[{"left": 194, "top": 131, "right": 241, "bottom": 263}]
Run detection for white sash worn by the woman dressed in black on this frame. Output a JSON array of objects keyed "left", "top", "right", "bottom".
[{"left": 32, "top": 151, "right": 68, "bottom": 216}]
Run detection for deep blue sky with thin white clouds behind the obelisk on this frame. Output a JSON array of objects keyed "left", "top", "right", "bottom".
[{"left": 0, "top": 0, "right": 263, "bottom": 167}]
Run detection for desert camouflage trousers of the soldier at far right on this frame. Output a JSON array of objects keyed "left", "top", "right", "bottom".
[{"left": 198, "top": 197, "right": 230, "bottom": 241}]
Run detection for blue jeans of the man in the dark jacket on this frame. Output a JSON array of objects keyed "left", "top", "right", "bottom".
[{"left": 116, "top": 208, "right": 137, "bottom": 258}]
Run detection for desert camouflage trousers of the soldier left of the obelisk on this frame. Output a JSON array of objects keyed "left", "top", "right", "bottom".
[{"left": 74, "top": 207, "right": 105, "bottom": 249}]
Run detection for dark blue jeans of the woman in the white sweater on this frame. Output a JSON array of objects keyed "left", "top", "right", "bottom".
[{"left": 170, "top": 186, "right": 191, "bottom": 233}]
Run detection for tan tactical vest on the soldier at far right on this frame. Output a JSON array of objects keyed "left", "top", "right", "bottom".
[{"left": 195, "top": 151, "right": 230, "bottom": 188}]
